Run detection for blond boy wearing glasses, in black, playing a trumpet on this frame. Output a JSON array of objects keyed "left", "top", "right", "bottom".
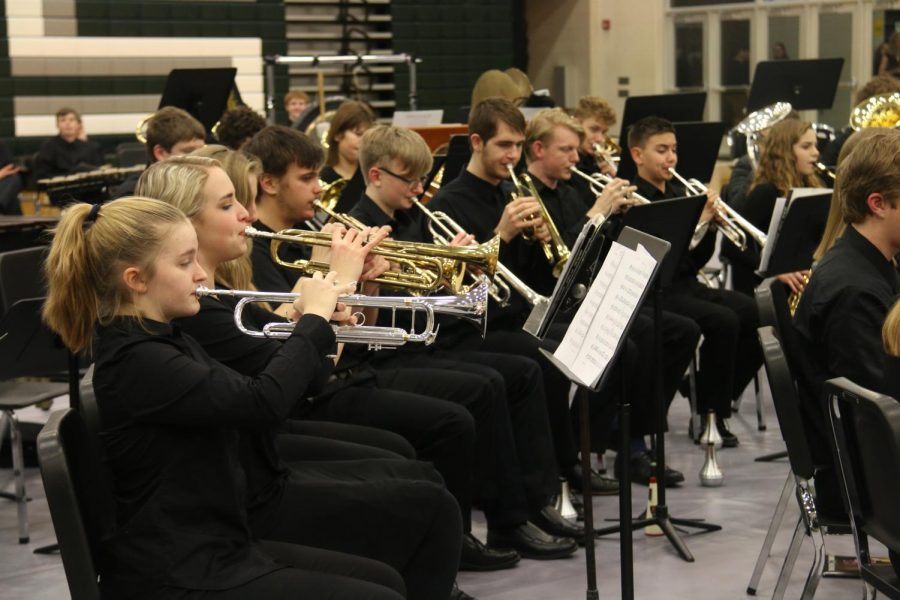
[{"left": 350, "top": 126, "right": 583, "bottom": 558}]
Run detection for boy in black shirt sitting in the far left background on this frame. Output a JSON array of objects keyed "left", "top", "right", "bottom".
[{"left": 34, "top": 108, "right": 104, "bottom": 179}]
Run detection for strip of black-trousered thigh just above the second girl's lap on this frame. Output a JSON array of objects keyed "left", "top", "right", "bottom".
[{"left": 278, "top": 419, "right": 416, "bottom": 460}]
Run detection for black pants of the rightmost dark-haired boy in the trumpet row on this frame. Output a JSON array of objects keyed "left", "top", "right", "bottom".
[{"left": 663, "top": 280, "right": 762, "bottom": 418}]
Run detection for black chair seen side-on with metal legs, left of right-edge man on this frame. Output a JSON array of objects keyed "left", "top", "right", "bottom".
[{"left": 747, "top": 327, "right": 849, "bottom": 600}]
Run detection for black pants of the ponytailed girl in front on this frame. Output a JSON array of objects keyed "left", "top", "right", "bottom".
[{"left": 156, "top": 541, "right": 406, "bottom": 600}]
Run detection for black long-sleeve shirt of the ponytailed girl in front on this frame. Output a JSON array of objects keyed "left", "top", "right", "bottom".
[{"left": 94, "top": 316, "right": 334, "bottom": 598}]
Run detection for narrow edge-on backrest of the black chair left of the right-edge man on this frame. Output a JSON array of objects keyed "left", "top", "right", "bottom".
[{"left": 758, "top": 326, "right": 815, "bottom": 479}]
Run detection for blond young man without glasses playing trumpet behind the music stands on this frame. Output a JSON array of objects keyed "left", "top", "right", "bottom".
[{"left": 520, "top": 108, "right": 700, "bottom": 484}]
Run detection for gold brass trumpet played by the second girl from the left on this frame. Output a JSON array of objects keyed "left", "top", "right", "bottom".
[{"left": 245, "top": 227, "right": 500, "bottom": 294}]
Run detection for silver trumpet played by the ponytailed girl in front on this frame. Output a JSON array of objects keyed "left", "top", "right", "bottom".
[{"left": 196, "top": 281, "right": 489, "bottom": 350}]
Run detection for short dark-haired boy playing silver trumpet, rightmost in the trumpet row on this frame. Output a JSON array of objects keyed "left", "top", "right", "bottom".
[{"left": 628, "top": 117, "right": 762, "bottom": 447}]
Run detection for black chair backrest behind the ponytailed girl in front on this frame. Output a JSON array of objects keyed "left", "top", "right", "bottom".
[{"left": 37, "top": 408, "right": 115, "bottom": 600}]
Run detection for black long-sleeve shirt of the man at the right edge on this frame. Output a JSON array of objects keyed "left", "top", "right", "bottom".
[{"left": 794, "top": 225, "right": 900, "bottom": 464}]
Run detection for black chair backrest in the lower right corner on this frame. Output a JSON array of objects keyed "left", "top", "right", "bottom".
[{"left": 824, "top": 378, "right": 900, "bottom": 552}]
